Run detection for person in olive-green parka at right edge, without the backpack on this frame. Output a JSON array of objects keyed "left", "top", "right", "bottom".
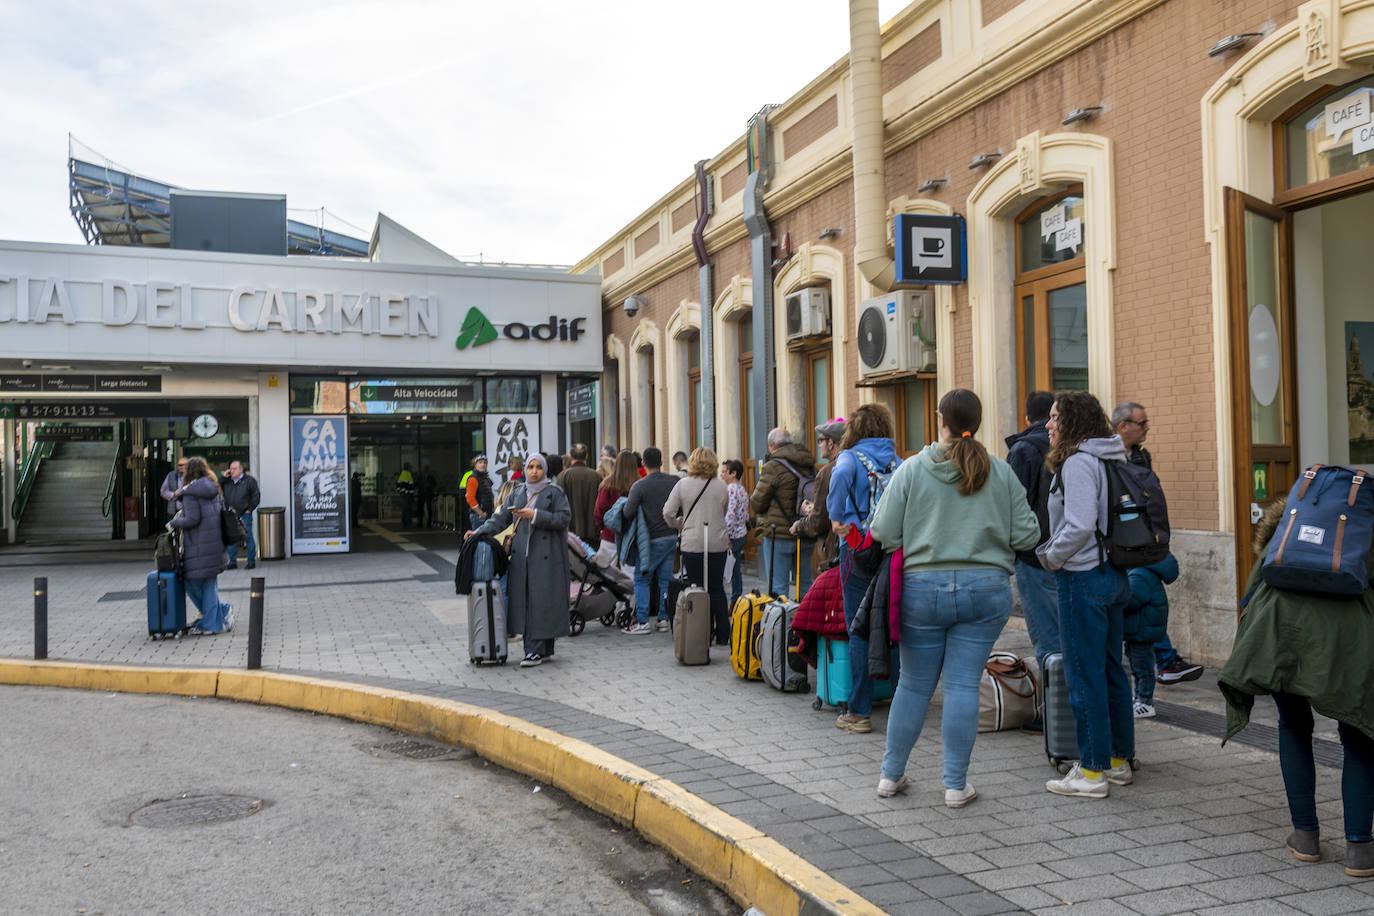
[{"left": 1219, "top": 500, "right": 1374, "bottom": 878}]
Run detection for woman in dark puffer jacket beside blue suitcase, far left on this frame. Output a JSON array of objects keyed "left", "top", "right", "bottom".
[{"left": 168, "top": 457, "right": 234, "bottom": 634}]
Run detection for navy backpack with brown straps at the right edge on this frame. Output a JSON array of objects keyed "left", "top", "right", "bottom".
[{"left": 1261, "top": 464, "right": 1374, "bottom": 595}]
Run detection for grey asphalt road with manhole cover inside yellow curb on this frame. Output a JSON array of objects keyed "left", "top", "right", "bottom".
[{"left": 0, "top": 687, "right": 739, "bottom": 916}]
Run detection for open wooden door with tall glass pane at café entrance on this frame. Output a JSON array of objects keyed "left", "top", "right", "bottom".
[{"left": 1226, "top": 188, "right": 1298, "bottom": 591}]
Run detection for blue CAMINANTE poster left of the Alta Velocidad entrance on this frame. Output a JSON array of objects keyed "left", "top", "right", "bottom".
[{"left": 291, "top": 416, "right": 349, "bottom": 553}]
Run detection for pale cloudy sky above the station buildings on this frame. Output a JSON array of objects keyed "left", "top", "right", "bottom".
[{"left": 0, "top": 0, "right": 905, "bottom": 264}]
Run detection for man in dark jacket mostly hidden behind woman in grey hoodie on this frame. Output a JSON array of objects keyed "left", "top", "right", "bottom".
[{"left": 1007, "top": 391, "right": 1059, "bottom": 666}]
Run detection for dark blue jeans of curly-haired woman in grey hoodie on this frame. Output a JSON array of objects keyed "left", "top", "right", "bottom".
[{"left": 1055, "top": 563, "right": 1135, "bottom": 769}]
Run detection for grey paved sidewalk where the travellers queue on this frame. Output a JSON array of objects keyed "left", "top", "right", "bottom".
[{"left": 0, "top": 534, "right": 1374, "bottom": 916}]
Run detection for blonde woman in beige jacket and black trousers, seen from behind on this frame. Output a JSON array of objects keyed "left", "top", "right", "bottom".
[{"left": 664, "top": 448, "right": 730, "bottom": 645}]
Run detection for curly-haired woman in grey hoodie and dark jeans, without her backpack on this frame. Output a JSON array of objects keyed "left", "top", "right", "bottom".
[{"left": 1036, "top": 391, "right": 1135, "bottom": 798}]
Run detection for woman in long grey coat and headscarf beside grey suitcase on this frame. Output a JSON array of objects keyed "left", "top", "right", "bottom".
[{"left": 463, "top": 453, "right": 573, "bottom": 667}]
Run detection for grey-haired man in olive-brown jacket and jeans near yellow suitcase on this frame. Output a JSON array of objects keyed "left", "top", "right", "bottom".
[{"left": 749, "top": 426, "right": 816, "bottom": 599}]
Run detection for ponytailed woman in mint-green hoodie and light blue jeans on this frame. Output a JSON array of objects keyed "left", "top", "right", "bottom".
[{"left": 870, "top": 389, "right": 1040, "bottom": 808}]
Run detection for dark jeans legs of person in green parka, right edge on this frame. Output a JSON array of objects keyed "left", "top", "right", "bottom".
[{"left": 1274, "top": 694, "right": 1374, "bottom": 843}]
